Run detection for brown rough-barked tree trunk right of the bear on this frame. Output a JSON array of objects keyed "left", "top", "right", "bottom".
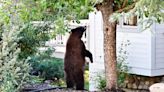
[{"left": 96, "top": 0, "right": 117, "bottom": 90}]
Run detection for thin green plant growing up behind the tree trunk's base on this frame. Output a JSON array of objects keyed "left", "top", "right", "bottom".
[{"left": 96, "top": 40, "right": 130, "bottom": 90}]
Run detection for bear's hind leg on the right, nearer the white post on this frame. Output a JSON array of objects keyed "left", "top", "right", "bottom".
[{"left": 75, "top": 70, "right": 84, "bottom": 90}]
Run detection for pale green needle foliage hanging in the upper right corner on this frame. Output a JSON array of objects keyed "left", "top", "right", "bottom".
[{"left": 109, "top": 0, "right": 164, "bottom": 25}]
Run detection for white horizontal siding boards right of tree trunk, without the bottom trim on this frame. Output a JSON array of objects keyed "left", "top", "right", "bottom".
[{"left": 117, "top": 28, "right": 151, "bottom": 69}]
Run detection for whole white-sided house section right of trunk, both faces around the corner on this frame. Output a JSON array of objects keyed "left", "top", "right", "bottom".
[{"left": 117, "top": 23, "right": 164, "bottom": 76}]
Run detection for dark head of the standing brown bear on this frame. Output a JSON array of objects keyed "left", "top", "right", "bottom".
[{"left": 71, "top": 26, "right": 86, "bottom": 38}]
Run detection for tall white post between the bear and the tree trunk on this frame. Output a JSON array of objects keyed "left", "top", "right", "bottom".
[{"left": 89, "top": 12, "right": 104, "bottom": 91}]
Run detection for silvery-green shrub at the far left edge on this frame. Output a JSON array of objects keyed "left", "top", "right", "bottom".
[{"left": 0, "top": 26, "right": 30, "bottom": 92}]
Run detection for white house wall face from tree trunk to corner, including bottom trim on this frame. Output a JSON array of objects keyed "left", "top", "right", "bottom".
[{"left": 116, "top": 27, "right": 154, "bottom": 75}]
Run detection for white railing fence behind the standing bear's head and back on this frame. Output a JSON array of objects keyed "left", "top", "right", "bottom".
[{"left": 46, "top": 20, "right": 89, "bottom": 58}]
